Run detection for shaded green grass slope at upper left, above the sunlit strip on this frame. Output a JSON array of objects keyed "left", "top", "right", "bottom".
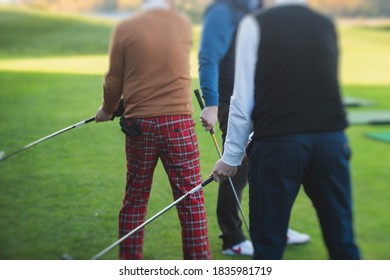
[{"left": 0, "top": 7, "right": 111, "bottom": 58}]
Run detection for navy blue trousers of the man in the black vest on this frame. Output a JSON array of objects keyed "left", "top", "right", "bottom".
[{"left": 248, "top": 132, "right": 360, "bottom": 260}]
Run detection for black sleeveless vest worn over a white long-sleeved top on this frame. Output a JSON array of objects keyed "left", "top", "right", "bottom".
[{"left": 252, "top": 5, "right": 347, "bottom": 139}]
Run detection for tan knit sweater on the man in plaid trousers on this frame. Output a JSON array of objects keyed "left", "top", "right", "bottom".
[{"left": 103, "top": 9, "right": 193, "bottom": 118}]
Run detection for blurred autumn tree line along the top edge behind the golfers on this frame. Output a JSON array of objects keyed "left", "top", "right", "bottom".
[{"left": 9, "top": 0, "right": 390, "bottom": 17}]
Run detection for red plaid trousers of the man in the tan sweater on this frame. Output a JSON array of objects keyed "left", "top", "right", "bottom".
[{"left": 119, "top": 116, "right": 210, "bottom": 259}]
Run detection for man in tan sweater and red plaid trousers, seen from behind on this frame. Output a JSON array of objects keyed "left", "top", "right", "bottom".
[{"left": 96, "top": 0, "right": 210, "bottom": 259}]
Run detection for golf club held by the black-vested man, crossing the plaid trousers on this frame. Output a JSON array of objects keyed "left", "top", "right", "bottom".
[{"left": 91, "top": 176, "right": 214, "bottom": 260}]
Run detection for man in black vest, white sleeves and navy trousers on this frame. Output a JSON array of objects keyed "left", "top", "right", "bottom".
[{"left": 213, "top": 0, "right": 360, "bottom": 259}]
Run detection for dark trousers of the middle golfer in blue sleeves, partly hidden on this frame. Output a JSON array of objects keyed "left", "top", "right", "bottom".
[{"left": 217, "top": 104, "right": 248, "bottom": 250}]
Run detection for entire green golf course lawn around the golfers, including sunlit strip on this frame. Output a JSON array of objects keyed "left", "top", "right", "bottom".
[{"left": 0, "top": 8, "right": 390, "bottom": 260}]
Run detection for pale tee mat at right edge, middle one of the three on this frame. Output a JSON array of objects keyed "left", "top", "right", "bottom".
[{"left": 347, "top": 110, "right": 390, "bottom": 125}]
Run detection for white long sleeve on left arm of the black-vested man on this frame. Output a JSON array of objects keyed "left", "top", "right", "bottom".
[{"left": 222, "top": 15, "right": 260, "bottom": 166}]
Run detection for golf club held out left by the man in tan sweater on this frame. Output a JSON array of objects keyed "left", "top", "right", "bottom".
[{"left": 0, "top": 99, "right": 124, "bottom": 161}]
